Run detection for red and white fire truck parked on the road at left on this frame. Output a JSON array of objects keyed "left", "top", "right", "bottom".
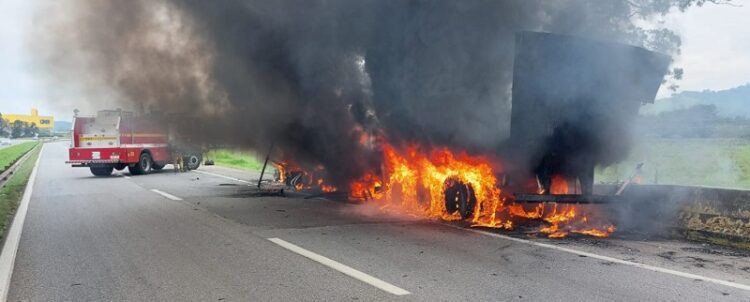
[{"left": 66, "top": 109, "right": 202, "bottom": 176}]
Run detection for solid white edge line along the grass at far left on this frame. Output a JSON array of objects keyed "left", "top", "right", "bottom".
[{"left": 0, "top": 144, "right": 45, "bottom": 302}]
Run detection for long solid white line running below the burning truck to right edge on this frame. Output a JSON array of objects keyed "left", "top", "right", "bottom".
[{"left": 441, "top": 223, "right": 750, "bottom": 291}]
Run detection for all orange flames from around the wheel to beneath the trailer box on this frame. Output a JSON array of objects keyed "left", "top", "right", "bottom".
[{"left": 349, "top": 144, "right": 615, "bottom": 238}]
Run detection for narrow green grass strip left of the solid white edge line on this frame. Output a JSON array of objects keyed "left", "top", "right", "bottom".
[{"left": 0, "top": 142, "right": 42, "bottom": 239}]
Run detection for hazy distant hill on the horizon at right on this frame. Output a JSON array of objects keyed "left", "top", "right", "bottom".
[{"left": 641, "top": 84, "right": 750, "bottom": 118}]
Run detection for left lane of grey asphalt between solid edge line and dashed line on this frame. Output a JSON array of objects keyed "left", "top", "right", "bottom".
[{"left": 8, "top": 144, "right": 389, "bottom": 301}]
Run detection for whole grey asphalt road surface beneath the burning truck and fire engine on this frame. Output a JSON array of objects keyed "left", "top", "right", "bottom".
[{"left": 8, "top": 143, "right": 750, "bottom": 301}]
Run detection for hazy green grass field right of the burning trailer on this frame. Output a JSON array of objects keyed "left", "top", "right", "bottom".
[{"left": 596, "top": 139, "right": 750, "bottom": 189}]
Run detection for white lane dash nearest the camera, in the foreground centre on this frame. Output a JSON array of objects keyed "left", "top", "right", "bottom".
[{"left": 268, "top": 238, "right": 410, "bottom": 296}]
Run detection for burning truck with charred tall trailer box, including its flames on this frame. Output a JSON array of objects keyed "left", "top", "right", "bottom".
[{"left": 268, "top": 32, "right": 670, "bottom": 238}]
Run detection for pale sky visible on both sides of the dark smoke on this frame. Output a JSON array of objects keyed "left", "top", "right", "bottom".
[{"left": 0, "top": 0, "right": 750, "bottom": 120}]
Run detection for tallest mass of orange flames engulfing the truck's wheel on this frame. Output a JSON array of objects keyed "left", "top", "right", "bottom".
[{"left": 350, "top": 144, "right": 511, "bottom": 228}]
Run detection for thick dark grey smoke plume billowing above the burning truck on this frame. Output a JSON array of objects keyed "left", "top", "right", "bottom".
[{"left": 33, "top": 0, "right": 679, "bottom": 184}]
